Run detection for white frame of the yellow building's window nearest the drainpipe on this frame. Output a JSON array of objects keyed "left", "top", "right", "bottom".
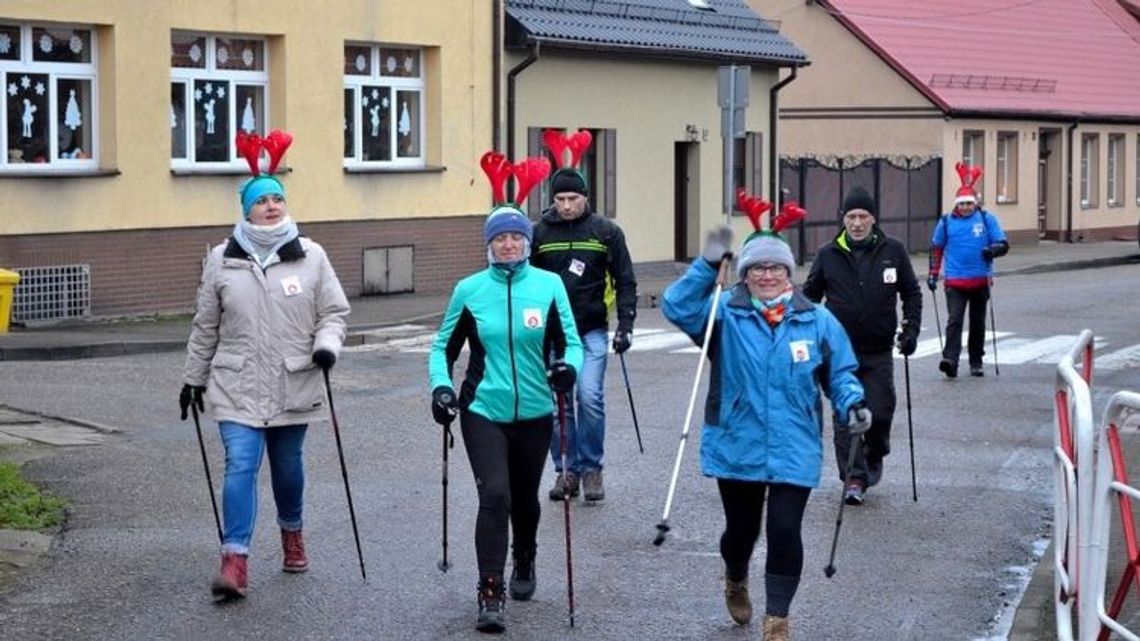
[{"left": 337, "top": 41, "right": 428, "bottom": 169}]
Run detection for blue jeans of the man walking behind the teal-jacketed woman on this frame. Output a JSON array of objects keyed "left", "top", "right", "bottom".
[{"left": 551, "top": 330, "right": 610, "bottom": 474}]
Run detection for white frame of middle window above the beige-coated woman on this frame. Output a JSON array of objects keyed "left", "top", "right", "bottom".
[{"left": 170, "top": 30, "right": 271, "bottom": 171}]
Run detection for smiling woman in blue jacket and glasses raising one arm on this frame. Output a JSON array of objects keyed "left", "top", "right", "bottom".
[{"left": 662, "top": 206, "right": 871, "bottom": 641}]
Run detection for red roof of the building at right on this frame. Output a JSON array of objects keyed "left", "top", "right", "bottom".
[{"left": 825, "top": 0, "right": 1140, "bottom": 119}]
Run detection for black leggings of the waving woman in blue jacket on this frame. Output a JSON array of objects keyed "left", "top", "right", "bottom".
[{"left": 717, "top": 479, "right": 812, "bottom": 581}]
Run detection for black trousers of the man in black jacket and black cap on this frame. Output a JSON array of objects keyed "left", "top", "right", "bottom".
[{"left": 832, "top": 350, "right": 897, "bottom": 486}]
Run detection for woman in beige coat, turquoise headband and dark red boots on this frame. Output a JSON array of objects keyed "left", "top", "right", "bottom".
[{"left": 179, "top": 156, "right": 349, "bottom": 599}]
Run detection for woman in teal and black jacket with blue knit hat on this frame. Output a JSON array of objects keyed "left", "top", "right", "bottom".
[{"left": 429, "top": 205, "right": 583, "bottom": 632}]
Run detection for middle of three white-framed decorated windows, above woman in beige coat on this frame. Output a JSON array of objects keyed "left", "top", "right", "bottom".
[{"left": 170, "top": 32, "right": 269, "bottom": 168}]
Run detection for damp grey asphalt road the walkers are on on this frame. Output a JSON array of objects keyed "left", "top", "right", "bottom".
[{"left": 0, "top": 262, "right": 1140, "bottom": 640}]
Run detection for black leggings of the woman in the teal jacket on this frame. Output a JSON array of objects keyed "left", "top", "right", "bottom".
[{"left": 459, "top": 412, "right": 554, "bottom": 576}]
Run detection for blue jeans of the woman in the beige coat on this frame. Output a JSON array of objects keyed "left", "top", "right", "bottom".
[{"left": 218, "top": 421, "right": 308, "bottom": 554}]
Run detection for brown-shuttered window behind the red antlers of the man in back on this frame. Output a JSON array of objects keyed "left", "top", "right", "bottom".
[{"left": 528, "top": 127, "right": 618, "bottom": 219}]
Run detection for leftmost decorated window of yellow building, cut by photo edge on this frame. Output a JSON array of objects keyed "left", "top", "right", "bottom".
[{"left": 0, "top": 24, "right": 98, "bottom": 171}]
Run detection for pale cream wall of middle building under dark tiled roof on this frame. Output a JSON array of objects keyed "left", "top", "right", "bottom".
[{"left": 504, "top": 51, "right": 776, "bottom": 262}]
